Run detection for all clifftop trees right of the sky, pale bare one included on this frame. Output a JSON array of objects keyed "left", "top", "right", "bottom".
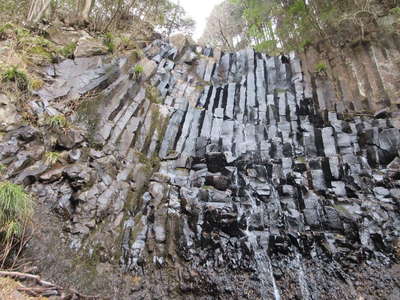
[{"left": 203, "top": 0, "right": 400, "bottom": 54}]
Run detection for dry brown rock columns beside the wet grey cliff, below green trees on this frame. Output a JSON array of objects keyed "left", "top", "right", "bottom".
[{"left": 301, "top": 34, "right": 400, "bottom": 114}]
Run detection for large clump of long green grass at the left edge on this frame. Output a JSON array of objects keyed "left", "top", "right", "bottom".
[{"left": 0, "top": 181, "right": 33, "bottom": 243}]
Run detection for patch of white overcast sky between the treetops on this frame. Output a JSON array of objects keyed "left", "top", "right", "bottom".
[{"left": 179, "top": 0, "right": 223, "bottom": 40}]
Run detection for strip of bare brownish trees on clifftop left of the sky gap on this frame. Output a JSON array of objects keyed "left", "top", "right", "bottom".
[{"left": 0, "top": 0, "right": 194, "bottom": 35}]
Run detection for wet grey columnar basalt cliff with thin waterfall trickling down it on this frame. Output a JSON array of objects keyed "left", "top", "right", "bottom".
[{"left": 0, "top": 40, "right": 400, "bottom": 300}]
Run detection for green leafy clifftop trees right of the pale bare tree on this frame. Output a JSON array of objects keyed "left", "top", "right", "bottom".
[{"left": 231, "top": 0, "right": 392, "bottom": 54}]
